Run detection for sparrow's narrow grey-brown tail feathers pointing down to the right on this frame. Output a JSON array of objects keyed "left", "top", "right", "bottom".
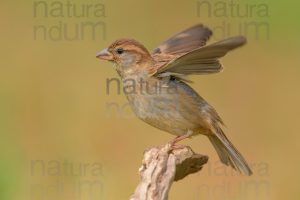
[{"left": 208, "top": 131, "right": 252, "bottom": 176}]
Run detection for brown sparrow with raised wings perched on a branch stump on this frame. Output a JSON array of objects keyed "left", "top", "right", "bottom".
[{"left": 97, "top": 25, "right": 252, "bottom": 175}]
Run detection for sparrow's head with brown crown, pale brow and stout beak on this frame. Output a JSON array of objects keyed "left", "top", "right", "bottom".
[{"left": 96, "top": 39, "right": 153, "bottom": 76}]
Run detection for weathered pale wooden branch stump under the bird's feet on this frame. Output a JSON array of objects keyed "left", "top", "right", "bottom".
[{"left": 130, "top": 144, "right": 208, "bottom": 200}]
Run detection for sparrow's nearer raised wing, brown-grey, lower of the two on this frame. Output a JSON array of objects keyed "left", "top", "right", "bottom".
[{"left": 153, "top": 36, "right": 246, "bottom": 76}]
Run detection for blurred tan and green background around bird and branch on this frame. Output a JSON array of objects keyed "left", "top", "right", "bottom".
[{"left": 0, "top": 0, "right": 300, "bottom": 200}]
